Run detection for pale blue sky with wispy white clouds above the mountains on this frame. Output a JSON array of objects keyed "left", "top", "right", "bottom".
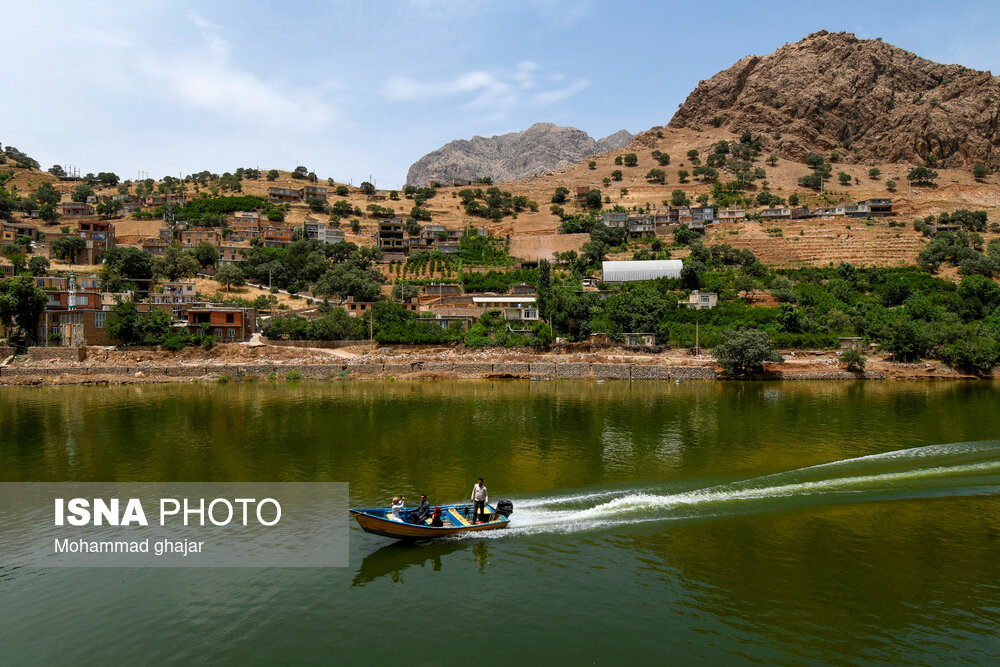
[{"left": 0, "top": 0, "right": 1000, "bottom": 188}]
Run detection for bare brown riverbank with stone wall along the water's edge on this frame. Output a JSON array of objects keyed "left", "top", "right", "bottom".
[{"left": 0, "top": 344, "right": 984, "bottom": 385}]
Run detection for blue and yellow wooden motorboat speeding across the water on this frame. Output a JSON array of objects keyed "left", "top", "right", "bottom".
[{"left": 351, "top": 500, "right": 514, "bottom": 540}]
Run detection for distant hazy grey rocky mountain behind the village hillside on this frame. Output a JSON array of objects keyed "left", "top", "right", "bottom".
[{"left": 406, "top": 123, "right": 632, "bottom": 186}]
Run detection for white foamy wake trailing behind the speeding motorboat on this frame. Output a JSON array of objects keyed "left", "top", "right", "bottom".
[{"left": 476, "top": 441, "right": 1000, "bottom": 539}]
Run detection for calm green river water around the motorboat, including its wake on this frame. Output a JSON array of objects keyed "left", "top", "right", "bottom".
[{"left": 0, "top": 381, "right": 1000, "bottom": 665}]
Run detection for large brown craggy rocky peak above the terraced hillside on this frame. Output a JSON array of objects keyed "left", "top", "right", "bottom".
[{"left": 669, "top": 30, "right": 1000, "bottom": 167}]
